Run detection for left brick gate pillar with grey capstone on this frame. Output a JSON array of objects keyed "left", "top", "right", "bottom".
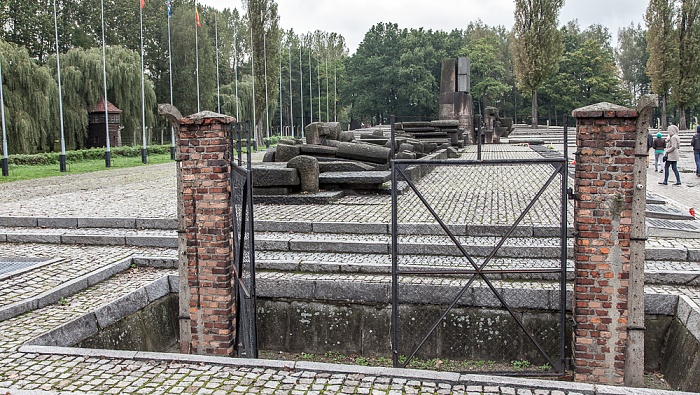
[{"left": 177, "top": 112, "right": 236, "bottom": 355}]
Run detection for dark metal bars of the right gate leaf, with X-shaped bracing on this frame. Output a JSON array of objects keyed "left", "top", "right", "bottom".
[{"left": 391, "top": 117, "right": 568, "bottom": 376}]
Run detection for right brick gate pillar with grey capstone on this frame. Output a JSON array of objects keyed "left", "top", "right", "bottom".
[{"left": 573, "top": 103, "right": 638, "bottom": 384}]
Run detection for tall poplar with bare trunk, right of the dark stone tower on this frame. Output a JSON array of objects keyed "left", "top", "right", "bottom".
[{"left": 510, "top": 0, "right": 564, "bottom": 129}]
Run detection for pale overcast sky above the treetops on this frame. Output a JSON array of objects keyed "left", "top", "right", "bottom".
[{"left": 199, "top": 0, "right": 648, "bottom": 54}]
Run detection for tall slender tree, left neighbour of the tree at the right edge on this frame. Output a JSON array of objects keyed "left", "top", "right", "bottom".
[{"left": 644, "top": 0, "right": 678, "bottom": 130}]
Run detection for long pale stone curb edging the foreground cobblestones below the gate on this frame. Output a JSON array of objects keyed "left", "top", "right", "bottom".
[{"left": 12, "top": 345, "right": 691, "bottom": 395}]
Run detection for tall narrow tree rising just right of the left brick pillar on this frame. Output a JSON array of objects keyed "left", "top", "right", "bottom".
[{"left": 243, "top": 0, "right": 281, "bottom": 141}]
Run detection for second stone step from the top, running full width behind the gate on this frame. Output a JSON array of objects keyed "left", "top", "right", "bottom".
[{"left": 0, "top": 228, "right": 700, "bottom": 262}]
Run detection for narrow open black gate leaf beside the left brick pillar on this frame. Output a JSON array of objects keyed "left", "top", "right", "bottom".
[{"left": 230, "top": 122, "right": 258, "bottom": 358}]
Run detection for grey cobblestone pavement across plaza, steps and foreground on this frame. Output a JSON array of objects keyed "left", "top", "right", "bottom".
[{"left": 0, "top": 147, "right": 700, "bottom": 395}]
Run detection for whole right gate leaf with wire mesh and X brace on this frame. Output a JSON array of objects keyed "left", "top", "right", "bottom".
[{"left": 391, "top": 122, "right": 568, "bottom": 376}]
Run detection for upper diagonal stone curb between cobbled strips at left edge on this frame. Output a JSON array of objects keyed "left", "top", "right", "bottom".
[{"left": 0, "top": 257, "right": 131, "bottom": 321}]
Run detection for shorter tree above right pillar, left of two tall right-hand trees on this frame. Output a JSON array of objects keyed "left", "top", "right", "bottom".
[{"left": 615, "top": 24, "right": 650, "bottom": 99}]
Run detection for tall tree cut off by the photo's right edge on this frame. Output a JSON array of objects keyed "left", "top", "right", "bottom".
[{"left": 671, "top": 0, "right": 700, "bottom": 130}]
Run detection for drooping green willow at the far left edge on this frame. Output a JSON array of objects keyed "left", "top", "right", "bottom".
[{"left": 0, "top": 40, "right": 59, "bottom": 154}]
